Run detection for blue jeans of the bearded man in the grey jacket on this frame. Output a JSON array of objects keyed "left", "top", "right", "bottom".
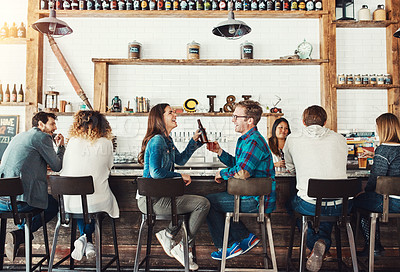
[{"left": 0, "top": 195, "right": 58, "bottom": 233}]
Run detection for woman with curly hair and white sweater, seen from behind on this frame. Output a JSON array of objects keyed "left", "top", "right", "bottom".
[{"left": 61, "top": 111, "right": 119, "bottom": 260}]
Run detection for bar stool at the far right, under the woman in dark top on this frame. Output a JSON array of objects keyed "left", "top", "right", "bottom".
[{"left": 356, "top": 176, "right": 400, "bottom": 272}]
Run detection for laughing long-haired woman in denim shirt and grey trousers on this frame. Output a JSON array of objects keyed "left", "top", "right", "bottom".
[{"left": 138, "top": 103, "right": 210, "bottom": 270}]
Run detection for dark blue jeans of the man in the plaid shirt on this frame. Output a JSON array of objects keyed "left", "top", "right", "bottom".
[{"left": 206, "top": 192, "right": 275, "bottom": 248}]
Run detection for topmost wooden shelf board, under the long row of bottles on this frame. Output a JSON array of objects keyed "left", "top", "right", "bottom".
[{"left": 37, "top": 10, "right": 328, "bottom": 18}]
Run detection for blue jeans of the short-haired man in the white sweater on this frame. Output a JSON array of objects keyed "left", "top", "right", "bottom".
[{"left": 292, "top": 195, "right": 352, "bottom": 251}]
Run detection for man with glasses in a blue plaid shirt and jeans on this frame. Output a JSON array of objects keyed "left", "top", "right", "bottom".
[{"left": 206, "top": 100, "right": 275, "bottom": 260}]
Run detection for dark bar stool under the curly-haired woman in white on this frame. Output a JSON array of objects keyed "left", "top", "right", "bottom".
[{"left": 48, "top": 176, "right": 120, "bottom": 272}]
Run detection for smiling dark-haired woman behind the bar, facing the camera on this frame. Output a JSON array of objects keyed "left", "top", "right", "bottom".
[{"left": 268, "top": 118, "right": 291, "bottom": 170}]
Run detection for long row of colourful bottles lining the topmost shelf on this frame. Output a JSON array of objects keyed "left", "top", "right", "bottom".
[{"left": 40, "top": 0, "right": 322, "bottom": 11}]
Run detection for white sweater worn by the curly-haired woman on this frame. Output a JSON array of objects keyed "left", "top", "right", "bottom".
[{"left": 60, "top": 137, "right": 119, "bottom": 218}]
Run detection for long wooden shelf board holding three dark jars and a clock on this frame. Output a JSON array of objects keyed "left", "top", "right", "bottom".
[{"left": 92, "top": 58, "right": 328, "bottom": 66}]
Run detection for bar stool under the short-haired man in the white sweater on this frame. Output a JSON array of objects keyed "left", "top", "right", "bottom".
[{"left": 286, "top": 178, "right": 361, "bottom": 272}]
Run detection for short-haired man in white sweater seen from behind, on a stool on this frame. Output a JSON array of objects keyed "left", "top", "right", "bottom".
[{"left": 283, "top": 105, "right": 347, "bottom": 271}]
